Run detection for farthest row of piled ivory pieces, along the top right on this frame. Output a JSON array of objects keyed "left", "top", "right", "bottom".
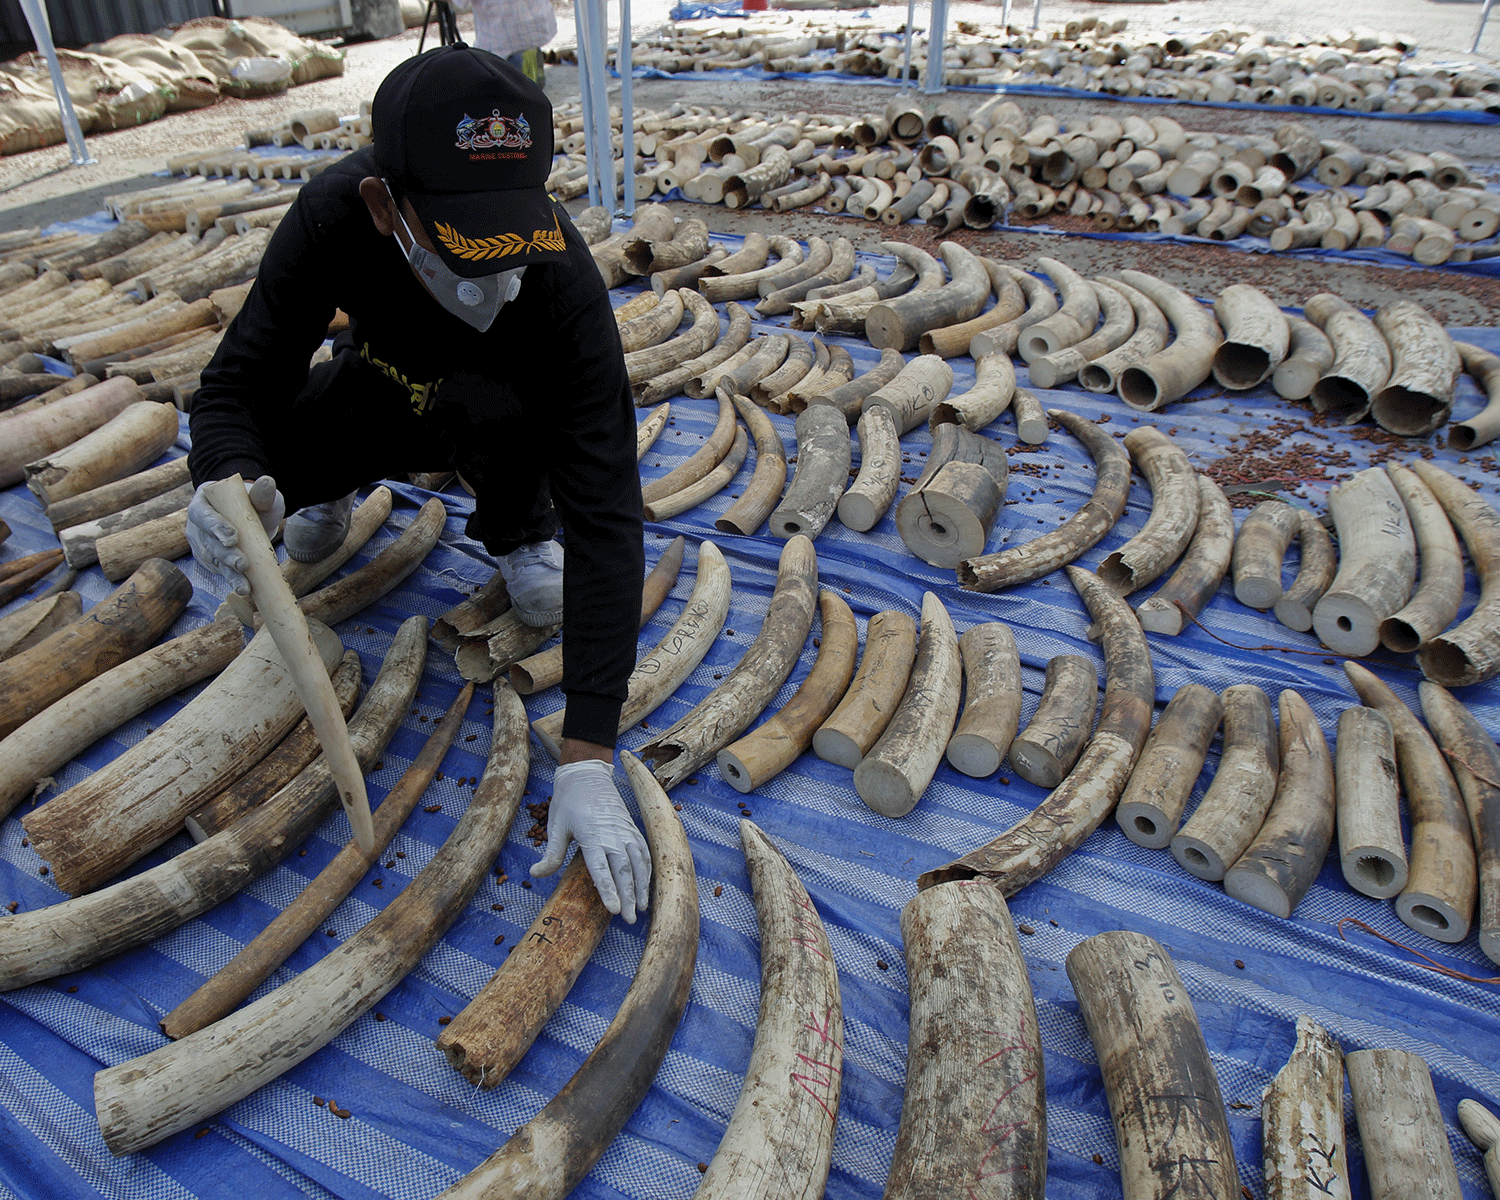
[{"left": 588, "top": 17, "right": 1500, "bottom": 113}]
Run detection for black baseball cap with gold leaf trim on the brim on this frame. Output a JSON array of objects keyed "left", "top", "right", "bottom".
[{"left": 371, "top": 44, "right": 567, "bottom": 278}]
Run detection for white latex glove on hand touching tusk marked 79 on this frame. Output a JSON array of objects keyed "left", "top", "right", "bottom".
[{"left": 531, "top": 759, "right": 651, "bottom": 926}]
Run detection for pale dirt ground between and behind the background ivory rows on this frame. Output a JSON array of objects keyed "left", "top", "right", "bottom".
[{"left": 0, "top": 0, "right": 1500, "bottom": 318}]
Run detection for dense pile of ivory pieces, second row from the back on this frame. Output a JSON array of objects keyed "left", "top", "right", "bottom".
[{"left": 549, "top": 99, "right": 1500, "bottom": 266}]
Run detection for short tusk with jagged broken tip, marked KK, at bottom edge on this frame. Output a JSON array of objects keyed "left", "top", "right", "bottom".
[{"left": 1260, "top": 1013, "right": 1352, "bottom": 1200}]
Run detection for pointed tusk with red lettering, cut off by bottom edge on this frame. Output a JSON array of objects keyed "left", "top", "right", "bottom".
[{"left": 693, "top": 821, "right": 845, "bottom": 1200}]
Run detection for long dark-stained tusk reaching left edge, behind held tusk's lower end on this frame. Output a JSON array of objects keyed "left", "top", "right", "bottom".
[{"left": 0, "top": 617, "right": 426, "bottom": 990}]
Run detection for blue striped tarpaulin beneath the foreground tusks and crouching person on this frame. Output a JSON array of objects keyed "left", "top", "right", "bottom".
[{"left": 0, "top": 228, "right": 1500, "bottom": 1200}]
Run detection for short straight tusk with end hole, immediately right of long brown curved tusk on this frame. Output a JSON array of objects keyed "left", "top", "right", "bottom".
[{"left": 1115, "top": 684, "right": 1224, "bottom": 851}]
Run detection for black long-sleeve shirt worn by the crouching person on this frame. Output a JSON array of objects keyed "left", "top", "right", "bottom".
[{"left": 191, "top": 149, "right": 645, "bottom": 746}]
